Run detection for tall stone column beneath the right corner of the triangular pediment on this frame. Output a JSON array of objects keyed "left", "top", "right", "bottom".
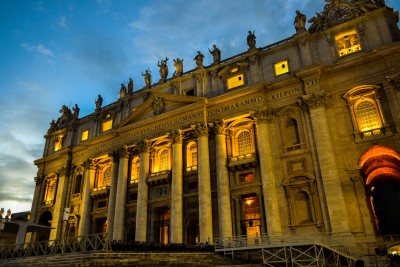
[{"left": 195, "top": 123, "right": 213, "bottom": 243}]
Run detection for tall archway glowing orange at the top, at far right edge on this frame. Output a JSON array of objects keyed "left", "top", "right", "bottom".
[{"left": 359, "top": 145, "right": 400, "bottom": 235}]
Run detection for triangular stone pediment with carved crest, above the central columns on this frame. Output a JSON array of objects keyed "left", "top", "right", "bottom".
[{"left": 117, "top": 93, "right": 207, "bottom": 128}]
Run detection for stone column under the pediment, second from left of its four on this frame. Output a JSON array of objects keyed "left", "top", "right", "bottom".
[{"left": 135, "top": 140, "right": 150, "bottom": 242}]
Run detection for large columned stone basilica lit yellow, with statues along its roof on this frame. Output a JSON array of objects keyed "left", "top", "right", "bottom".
[{"left": 30, "top": 0, "right": 400, "bottom": 260}]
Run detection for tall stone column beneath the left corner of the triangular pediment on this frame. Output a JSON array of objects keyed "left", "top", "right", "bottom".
[{"left": 113, "top": 147, "right": 129, "bottom": 240}]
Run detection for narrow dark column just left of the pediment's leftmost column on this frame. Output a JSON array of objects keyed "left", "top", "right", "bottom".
[{"left": 107, "top": 151, "right": 119, "bottom": 240}]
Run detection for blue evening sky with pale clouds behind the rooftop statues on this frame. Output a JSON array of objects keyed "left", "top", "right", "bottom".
[{"left": 0, "top": 0, "right": 400, "bottom": 212}]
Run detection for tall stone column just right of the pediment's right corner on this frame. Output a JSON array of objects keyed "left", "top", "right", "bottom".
[{"left": 215, "top": 122, "right": 232, "bottom": 239}]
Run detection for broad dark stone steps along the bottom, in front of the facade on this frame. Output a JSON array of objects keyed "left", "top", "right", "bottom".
[{"left": 0, "top": 252, "right": 262, "bottom": 267}]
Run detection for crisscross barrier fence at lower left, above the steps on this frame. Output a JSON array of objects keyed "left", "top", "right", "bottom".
[{"left": 0, "top": 234, "right": 111, "bottom": 259}]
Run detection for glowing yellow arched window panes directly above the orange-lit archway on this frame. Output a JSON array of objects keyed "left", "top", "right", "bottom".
[{"left": 355, "top": 100, "right": 382, "bottom": 132}]
